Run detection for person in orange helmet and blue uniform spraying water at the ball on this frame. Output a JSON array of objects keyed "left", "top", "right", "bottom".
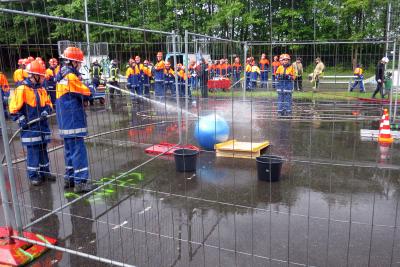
[{"left": 56, "top": 47, "right": 93, "bottom": 193}]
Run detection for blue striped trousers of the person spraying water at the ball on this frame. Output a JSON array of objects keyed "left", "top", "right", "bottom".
[{"left": 64, "top": 137, "right": 89, "bottom": 184}]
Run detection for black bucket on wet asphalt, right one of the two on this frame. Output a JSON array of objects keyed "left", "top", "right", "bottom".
[{"left": 256, "top": 155, "right": 283, "bottom": 182}]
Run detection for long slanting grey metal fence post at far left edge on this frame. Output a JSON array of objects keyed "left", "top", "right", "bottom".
[{"left": 0, "top": 99, "right": 22, "bottom": 235}]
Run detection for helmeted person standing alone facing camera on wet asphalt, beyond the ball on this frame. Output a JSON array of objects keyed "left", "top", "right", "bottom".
[{"left": 275, "top": 54, "right": 294, "bottom": 116}]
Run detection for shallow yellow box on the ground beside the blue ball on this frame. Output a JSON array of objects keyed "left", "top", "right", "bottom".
[{"left": 214, "top": 140, "right": 269, "bottom": 159}]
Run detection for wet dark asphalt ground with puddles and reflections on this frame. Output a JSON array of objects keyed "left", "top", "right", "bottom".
[{"left": 0, "top": 99, "right": 400, "bottom": 266}]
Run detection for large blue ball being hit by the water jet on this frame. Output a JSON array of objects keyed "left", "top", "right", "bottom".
[{"left": 194, "top": 114, "right": 229, "bottom": 150}]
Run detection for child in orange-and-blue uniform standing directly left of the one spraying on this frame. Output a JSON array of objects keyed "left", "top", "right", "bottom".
[{"left": 9, "top": 60, "right": 56, "bottom": 186}]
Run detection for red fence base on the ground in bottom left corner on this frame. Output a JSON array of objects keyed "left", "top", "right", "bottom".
[{"left": 0, "top": 227, "right": 57, "bottom": 266}]
